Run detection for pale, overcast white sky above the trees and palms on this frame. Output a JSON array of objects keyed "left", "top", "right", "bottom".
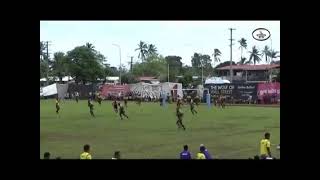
[{"left": 40, "top": 21, "right": 280, "bottom": 67}]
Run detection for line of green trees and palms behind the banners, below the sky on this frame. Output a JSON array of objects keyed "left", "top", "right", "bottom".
[{"left": 40, "top": 38, "right": 279, "bottom": 87}]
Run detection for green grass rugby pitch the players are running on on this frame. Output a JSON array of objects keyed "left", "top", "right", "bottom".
[{"left": 40, "top": 99, "right": 280, "bottom": 159}]
